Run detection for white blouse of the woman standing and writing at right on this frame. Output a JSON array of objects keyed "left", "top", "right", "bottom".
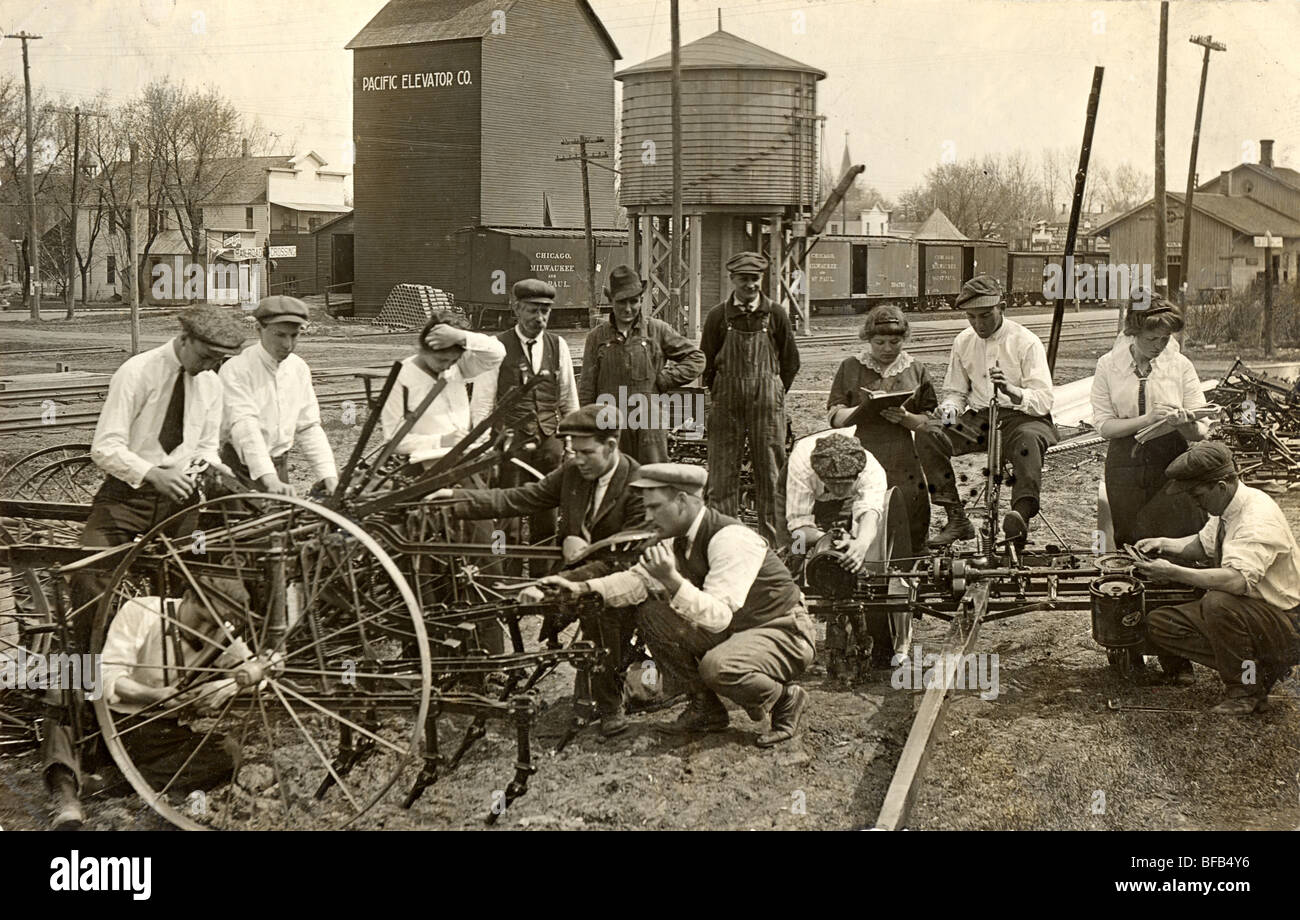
[{"left": 1092, "top": 335, "right": 1205, "bottom": 430}]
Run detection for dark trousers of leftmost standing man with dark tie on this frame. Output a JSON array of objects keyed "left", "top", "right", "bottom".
[{"left": 40, "top": 477, "right": 199, "bottom": 789}]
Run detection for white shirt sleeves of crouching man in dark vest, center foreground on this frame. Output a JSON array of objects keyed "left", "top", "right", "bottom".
[{"left": 586, "top": 507, "right": 767, "bottom": 633}]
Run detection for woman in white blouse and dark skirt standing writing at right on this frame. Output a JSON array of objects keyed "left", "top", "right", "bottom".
[{"left": 1092, "top": 300, "right": 1206, "bottom": 548}]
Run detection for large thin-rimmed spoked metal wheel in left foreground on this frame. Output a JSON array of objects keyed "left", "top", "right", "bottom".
[{"left": 91, "top": 494, "right": 430, "bottom": 829}]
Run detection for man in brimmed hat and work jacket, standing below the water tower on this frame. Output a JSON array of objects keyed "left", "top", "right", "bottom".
[{"left": 577, "top": 265, "right": 705, "bottom": 463}]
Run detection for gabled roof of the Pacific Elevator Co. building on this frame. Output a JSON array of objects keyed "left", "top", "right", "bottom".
[{"left": 343, "top": 0, "right": 623, "bottom": 61}]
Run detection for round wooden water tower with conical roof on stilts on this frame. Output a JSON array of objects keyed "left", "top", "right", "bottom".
[{"left": 615, "top": 29, "right": 826, "bottom": 335}]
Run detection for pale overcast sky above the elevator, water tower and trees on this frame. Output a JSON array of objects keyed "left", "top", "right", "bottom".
[{"left": 0, "top": 0, "right": 1300, "bottom": 196}]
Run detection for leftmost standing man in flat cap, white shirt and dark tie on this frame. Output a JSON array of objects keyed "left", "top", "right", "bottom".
[{"left": 42, "top": 304, "right": 246, "bottom": 826}]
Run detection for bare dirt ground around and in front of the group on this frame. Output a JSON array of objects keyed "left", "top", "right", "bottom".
[{"left": 0, "top": 310, "right": 1300, "bottom": 830}]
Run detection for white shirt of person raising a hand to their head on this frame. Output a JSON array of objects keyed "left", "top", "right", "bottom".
[{"left": 380, "top": 331, "right": 506, "bottom": 461}]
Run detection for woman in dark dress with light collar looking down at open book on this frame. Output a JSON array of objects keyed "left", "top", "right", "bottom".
[{"left": 827, "top": 304, "right": 939, "bottom": 552}]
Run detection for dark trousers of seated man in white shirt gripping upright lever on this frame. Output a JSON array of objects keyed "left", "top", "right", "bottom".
[{"left": 915, "top": 408, "right": 1061, "bottom": 516}]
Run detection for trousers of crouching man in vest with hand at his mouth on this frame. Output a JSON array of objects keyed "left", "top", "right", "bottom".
[{"left": 637, "top": 600, "right": 814, "bottom": 719}]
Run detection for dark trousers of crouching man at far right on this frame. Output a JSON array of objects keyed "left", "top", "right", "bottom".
[{"left": 1147, "top": 591, "right": 1300, "bottom": 696}]
